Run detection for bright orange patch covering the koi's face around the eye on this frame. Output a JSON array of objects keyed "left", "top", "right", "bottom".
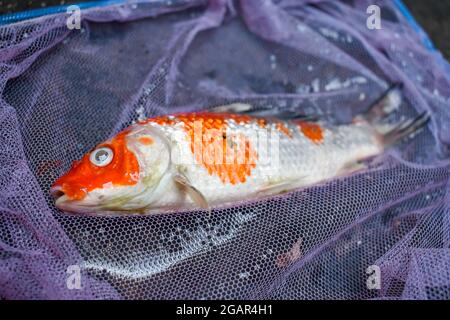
[{"left": 53, "top": 130, "right": 139, "bottom": 200}]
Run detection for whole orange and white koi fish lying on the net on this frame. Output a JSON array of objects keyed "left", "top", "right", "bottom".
[{"left": 50, "top": 85, "right": 429, "bottom": 214}]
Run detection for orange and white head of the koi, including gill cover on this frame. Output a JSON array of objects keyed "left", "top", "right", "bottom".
[{"left": 50, "top": 125, "right": 170, "bottom": 213}]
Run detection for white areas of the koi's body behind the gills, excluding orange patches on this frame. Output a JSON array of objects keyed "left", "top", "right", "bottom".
[{"left": 145, "top": 114, "right": 383, "bottom": 209}]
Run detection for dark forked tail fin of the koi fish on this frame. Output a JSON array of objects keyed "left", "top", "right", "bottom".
[{"left": 364, "top": 83, "right": 430, "bottom": 148}]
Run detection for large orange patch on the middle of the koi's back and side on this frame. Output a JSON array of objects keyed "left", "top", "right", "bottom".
[{"left": 148, "top": 112, "right": 258, "bottom": 184}]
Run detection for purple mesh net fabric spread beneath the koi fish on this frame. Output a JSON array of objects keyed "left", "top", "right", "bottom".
[{"left": 0, "top": 0, "right": 450, "bottom": 299}]
